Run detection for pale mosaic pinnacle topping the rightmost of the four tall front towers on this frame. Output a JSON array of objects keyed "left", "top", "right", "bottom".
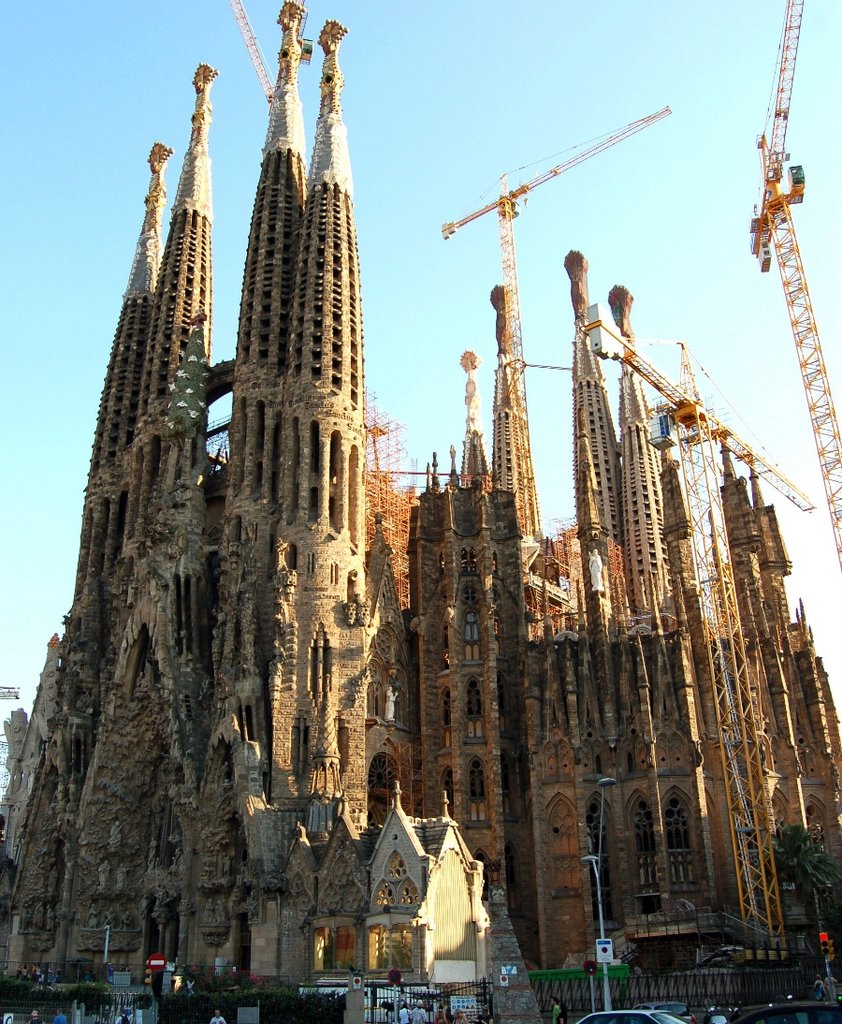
[{"left": 307, "top": 22, "right": 353, "bottom": 195}]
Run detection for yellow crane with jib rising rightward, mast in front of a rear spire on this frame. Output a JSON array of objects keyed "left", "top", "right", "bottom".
[{"left": 441, "top": 106, "right": 672, "bottom": 536}]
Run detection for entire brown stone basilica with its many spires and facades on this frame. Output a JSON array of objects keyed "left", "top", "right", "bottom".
[{"left": 3, "top": 0, "right": 842, "bottom": 981}]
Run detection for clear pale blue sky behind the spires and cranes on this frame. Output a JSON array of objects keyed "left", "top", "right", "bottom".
[{"left": 0, "top": 0, "right": 842, "bottom": 710}]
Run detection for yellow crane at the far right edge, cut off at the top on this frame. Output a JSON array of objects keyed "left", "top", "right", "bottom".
[{"left": 751, "top": 0, "right": 842, "bottom": 567}]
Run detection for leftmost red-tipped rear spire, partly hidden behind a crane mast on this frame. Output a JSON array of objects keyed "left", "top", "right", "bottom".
[{"left": 491, "top": 285, "right": 541, "bottom": 541}]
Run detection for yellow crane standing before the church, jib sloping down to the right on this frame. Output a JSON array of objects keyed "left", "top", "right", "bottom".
[{"left": 585, "top": 305, "right": 813, "bottom": 941}]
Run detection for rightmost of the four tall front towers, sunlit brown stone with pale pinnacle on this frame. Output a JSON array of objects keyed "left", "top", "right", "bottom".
[{"left": 272, "top": 22, "right": 369, "bottom": 831}]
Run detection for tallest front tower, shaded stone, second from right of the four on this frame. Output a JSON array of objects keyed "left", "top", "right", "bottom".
[{"left": 214, "top": 0, "right": 306, "bottom": 790}]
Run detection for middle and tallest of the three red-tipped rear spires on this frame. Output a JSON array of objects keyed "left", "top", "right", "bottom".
[{"left": 564, "top": 251, "right": 623, "bottom": 544}]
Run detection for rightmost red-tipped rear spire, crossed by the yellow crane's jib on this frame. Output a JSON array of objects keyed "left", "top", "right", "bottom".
[{"left": 608, "top": 285, "right": 669, "bottom": 612}]
